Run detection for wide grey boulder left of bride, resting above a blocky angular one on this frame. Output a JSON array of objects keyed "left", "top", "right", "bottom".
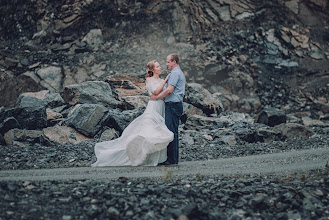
[{"left": 61, "top": 81, "right": 122, "bottom": 108}]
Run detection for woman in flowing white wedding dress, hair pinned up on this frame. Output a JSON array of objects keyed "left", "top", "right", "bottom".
[{"left": 91, "top": 60, "right": 174, "bottom": 167}]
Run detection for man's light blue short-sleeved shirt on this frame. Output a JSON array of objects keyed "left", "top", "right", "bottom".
[{"left": 165, "top": 66, "right": 186, "bottom": 102}]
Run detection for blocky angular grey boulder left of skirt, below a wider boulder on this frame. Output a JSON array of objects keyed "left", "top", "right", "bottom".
[{"left": 64, "top": 104, "right": 108, "bottom": 137}]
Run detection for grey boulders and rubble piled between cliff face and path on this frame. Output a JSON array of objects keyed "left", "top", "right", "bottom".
[{"left": 0, "top": 74, "right": 329, "bottom": 169}]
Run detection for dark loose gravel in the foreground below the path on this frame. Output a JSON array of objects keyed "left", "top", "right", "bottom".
[{"left": 0, "top": 169, "right": 329, "bottom": 220}]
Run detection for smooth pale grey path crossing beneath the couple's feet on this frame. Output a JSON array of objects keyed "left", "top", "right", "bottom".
[{"left": 0, "top": 148, "right": 329, "bottom": 181}]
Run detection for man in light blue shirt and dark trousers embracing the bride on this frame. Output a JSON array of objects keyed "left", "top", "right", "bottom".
[{"left": 150, "top": 53, "right": 186, "bottom": 165}]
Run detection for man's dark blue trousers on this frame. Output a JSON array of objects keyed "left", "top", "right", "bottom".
[{"left": 165, "top": 102, "right": 183, "bottom": 164}]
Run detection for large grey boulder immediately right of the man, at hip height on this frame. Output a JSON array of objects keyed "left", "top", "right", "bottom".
[{"left": 185, "top": 83, "right": 222, "bottom": 115}]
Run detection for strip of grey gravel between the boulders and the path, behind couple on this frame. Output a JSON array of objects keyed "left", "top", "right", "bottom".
[{"left": 0, "top": 130, "right": 329, "bottom": 170}]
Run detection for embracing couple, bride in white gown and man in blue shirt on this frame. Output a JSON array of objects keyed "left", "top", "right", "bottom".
[{"left": 92, "top": 54, "right": 186, "bottom": 167}]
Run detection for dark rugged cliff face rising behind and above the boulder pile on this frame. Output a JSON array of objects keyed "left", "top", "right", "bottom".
[{"left": 0, "top": 0, "right": 329, "bottom": 112}]
